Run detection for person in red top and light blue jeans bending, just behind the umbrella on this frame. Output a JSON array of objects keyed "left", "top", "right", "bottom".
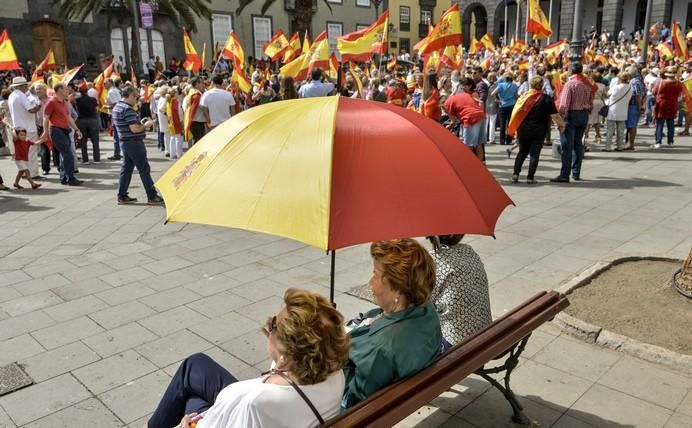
[{"left": 444, "top": 78, "right": 487, "bottom": 162}]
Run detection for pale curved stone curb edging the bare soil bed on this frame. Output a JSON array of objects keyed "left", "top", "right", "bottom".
[{"left": 553, "top": 255, "right": 692, "bottom": 374}]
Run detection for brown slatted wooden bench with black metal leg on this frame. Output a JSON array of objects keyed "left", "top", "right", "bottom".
[{"left": 322, "top": 291, "right": 569, "bottom": 428}]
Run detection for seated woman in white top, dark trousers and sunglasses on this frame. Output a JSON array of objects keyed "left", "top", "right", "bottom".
[{"left": 144, "top": 288, "right": 350, "bottom": 428}]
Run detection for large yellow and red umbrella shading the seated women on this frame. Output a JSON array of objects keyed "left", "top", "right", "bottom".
[{"left": 156, "top": 97, "right": 512, "bottom": 302}]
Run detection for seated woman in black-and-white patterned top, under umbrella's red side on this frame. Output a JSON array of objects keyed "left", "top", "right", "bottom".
[{"left": 428, "top": 235, "right": 492, "bottom": 350}]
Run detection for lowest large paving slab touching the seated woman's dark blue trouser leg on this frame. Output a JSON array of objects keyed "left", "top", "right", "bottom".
[{"left": 98, "top": 370, "right": 170, "bottom": 424}]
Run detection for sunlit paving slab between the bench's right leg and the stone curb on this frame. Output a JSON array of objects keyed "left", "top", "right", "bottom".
[{"left": 533, "top": 336, "right": 621, "bottom": 381}]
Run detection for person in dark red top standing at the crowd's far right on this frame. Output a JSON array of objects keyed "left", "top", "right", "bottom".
[{"left": 651, "top": 66, "right": 682, "bottom": 149}]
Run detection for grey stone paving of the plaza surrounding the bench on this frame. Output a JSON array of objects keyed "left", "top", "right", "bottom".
[{"left": 0, "top": 129, "right": 692, "bottom": 428}]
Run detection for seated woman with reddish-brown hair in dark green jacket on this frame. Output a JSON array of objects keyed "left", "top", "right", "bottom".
[{"left": 341, "top": 239, "right": 442, "bottom": 409}]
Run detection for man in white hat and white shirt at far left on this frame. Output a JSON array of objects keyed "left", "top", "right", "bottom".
[{"left": 8, "top": 76, "right": 41, "bottom": 178}]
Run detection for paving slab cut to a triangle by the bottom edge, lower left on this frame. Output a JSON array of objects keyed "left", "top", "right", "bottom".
[{"left": 20, "top": 398, "right": 123, "bottom": 428}]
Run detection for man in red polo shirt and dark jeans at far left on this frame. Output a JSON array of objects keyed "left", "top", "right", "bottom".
[{"left": 41, "top": 83, "right": 82, "bottom": 186}]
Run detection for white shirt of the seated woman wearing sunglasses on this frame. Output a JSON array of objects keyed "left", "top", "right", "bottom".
[{"left": 197, "top": 370, "right": 346, "bottom": 428}]
